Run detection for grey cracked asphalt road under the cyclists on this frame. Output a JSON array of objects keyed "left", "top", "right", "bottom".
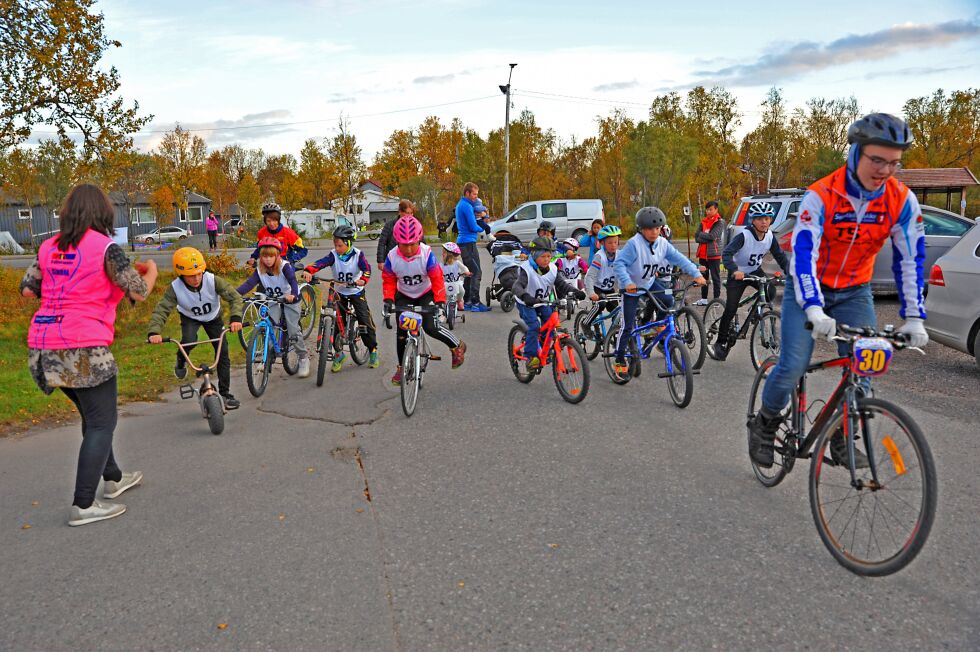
[{"left": 0, "top": 246, "right": 980, "bottom": 650}]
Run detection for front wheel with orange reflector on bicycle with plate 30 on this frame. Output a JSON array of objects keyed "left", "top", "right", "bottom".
[{"left": 810, "top": 398, "right": 938, "bottom": 576}]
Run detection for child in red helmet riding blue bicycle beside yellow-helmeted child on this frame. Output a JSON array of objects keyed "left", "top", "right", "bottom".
[{"left": 238, "top": 238, "right": 310, "bottom": 378}]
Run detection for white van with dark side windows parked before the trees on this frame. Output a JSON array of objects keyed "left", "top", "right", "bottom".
[{"left": 490, "top": 199, "right": 605, "bottom": 242}]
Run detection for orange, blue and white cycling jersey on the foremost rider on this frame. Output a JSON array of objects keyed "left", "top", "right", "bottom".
[{"left": 791, "top": 167, "right": 926, "bottom": 319}]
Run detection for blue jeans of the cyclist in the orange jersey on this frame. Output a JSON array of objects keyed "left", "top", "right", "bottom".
[{"left": 762, "top": 283, "right": 878, "bottom": 414}]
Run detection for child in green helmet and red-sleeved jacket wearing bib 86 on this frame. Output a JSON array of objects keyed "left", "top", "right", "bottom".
[{"left": 299, "top": 224, "right": 378, "bottom": 373}]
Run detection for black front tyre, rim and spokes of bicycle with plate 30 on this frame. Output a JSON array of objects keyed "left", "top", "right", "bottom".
[{"left": 809, "top": 398, "right": 939, "bottom": 577}]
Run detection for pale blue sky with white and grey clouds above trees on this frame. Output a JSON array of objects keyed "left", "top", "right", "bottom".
[{"left": 97, "top": 0, "right": 980, "bottom": 162}]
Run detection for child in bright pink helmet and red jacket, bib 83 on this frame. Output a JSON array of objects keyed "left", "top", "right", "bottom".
[{"left": 381, "top": 216, "right": 466, "bottom": 385}]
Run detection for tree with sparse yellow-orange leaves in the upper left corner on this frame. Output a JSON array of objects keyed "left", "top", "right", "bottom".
[{"left": 0, "top": 0, "right": 152, "bottom": 151}]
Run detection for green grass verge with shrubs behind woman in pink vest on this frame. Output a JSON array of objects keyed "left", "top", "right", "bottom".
[{"left": 0, "top": 266, "right": 245, "bottom": 436}]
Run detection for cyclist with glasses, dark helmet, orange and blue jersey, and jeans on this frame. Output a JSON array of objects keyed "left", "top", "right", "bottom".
[{"left": 749, "top": 113, "right": 929, "bottom": 467}]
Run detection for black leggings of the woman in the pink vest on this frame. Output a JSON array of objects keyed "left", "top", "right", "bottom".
[{"left": 61, "top": 376, "right": 122, "bottom": 509}]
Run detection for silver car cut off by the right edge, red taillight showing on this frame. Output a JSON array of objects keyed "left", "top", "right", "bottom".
[{"left": 926, "top": 217, "right": 980, "bottom": 367}]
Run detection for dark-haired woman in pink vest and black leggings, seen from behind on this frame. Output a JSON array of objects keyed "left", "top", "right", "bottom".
[{"left": 20, "top": 184, "right": 157, "bottom": 525}]
